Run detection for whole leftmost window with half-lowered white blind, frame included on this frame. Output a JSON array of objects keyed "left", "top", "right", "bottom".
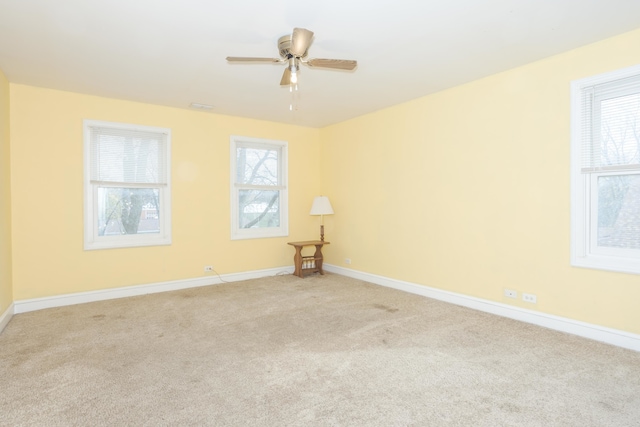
[{"left": 84, "top": 120, "right": 171, "bottom": 250}]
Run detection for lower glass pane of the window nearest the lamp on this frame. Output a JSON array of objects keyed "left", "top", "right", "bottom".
[{"left": 238, "top": 190, "right": 280, "bottom": 228}]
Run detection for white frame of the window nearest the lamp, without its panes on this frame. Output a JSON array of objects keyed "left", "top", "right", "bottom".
[{"left": 230, "top": 135, "right": 289, "bottom": 240}]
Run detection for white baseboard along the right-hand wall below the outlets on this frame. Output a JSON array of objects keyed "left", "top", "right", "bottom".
[{"left": 323, "top": 264, "right": 640, "bottom": 351}]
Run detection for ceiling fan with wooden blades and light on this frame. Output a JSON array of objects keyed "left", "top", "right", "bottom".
[{"left": 227, "top": 28, "right": 358, "bottom": 86}]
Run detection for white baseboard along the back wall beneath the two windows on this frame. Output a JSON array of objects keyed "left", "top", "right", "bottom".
[{"left": 13, "top": 267, "right": 293, "bottom": 314}]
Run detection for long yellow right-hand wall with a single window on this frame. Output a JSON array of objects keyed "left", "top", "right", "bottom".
[{"left": 321, "top": 27, "right": 640, "bottom": 333}]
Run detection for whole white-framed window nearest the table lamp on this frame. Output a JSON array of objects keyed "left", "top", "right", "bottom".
[{"left": 231, "top": 136, "right": 289, "bottom": 240}]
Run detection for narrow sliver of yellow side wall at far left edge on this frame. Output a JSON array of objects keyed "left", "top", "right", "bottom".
[{"left": 0, "top": 70, "right": 13, "bottom": 315}]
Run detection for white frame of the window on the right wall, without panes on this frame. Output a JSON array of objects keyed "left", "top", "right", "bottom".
[{"left": 571, "top": 65, "right": 640, "bottom": 274}]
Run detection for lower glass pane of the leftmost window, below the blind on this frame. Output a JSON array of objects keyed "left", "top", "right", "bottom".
[{"left": 98, "top": 187, "right": 160, "bottom": 236}]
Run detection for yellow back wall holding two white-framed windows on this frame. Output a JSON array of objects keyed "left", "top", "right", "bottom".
[{"left": 10, "top": 84, "right": 320, "bottom": 300}]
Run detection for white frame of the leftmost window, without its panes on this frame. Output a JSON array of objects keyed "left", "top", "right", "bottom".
[{"left": 83, "top": 120, "right": 171, "bottom": 250}]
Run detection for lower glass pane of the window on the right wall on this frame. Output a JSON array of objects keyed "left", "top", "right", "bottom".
[{"left": 598, "top": 175, "right": 640, "bottom": 249}]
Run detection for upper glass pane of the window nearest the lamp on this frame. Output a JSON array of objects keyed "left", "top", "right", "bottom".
[{"left": 236, "top": 147, "right": 279, "bottom": 185}]
